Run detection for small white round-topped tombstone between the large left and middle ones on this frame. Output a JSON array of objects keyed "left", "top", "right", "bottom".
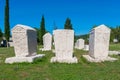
[{"left": 42, "top": 33, "right": 52, "bottom": 51}]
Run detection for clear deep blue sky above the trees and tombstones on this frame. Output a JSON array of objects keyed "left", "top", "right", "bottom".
[{"left": 0, "top": 0, "right": 120, "bottom": 35}]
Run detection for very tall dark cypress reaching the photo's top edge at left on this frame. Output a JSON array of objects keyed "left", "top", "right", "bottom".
[{"left": 4, "top": 0, "right": 10, "bottom": 42}]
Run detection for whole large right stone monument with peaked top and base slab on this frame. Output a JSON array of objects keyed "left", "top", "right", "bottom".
[{"left": 83, "top": 25, "right": 116, "bottom": 62}]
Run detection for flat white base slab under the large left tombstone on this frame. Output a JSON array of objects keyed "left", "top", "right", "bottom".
[{"left": 5, "top": 54, "right": 45, "bottom": 64}]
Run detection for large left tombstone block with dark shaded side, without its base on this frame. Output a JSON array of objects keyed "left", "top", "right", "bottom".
[{"left": 12, "top": 25, "right": 37, "bottom": 56}]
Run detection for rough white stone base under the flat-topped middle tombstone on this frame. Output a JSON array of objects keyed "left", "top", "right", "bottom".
[{"left": 50, "top": 57, "right": 78, "bottom": 63}]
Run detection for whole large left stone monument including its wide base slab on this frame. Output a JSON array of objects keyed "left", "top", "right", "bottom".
[{"left": 5, "top": 24, "right": 44, "bottom": 63}]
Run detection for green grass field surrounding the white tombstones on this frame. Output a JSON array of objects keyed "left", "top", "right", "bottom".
[{"left": 0, "top": 44, "right": 120, "bottom": 80}]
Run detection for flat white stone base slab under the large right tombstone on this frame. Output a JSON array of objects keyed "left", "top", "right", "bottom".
[{"left": 83, "top": 55, "right": 117, "bottom": 62}]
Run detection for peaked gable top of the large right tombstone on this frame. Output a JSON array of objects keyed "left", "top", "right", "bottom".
[{"left": 91, "top": 24, "right": 110, "bottom": 33}]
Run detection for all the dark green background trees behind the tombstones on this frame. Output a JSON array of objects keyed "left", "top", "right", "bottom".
[{"left": 0, "top": 0, "right": 120, "bottom": 45}]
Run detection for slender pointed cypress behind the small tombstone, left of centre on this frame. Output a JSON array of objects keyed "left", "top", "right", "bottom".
[{"left": 39, "top": 16, "right": 46, "bottom": 45}]
